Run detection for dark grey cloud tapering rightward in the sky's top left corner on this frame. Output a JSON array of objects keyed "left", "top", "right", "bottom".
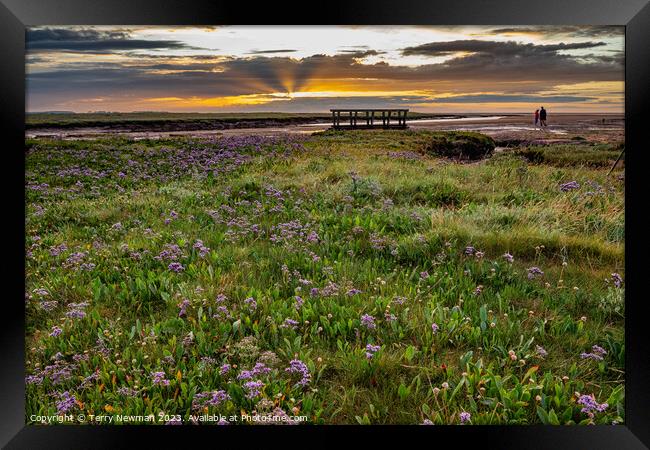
[{"left": 26, "top": 28, "right": 197, "bottom": 52}]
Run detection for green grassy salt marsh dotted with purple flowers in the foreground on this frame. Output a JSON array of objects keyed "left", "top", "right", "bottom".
[{"left": 25, "top": 131, "right": 625, "bottom": 424}]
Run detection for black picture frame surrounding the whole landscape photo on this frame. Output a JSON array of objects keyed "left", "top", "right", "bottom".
[{"left": 0, "top": 0, "right": 650, "bottom": 449}]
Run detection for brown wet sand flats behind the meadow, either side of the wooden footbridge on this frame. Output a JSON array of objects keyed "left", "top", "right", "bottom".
[{"left": 25, "top": 113, "right": 625, "bottom": 145}]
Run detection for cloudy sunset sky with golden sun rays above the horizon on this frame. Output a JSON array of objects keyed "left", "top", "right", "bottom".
[{"left": 26, "top": 25, "right": 625, "bottom": 113}]
